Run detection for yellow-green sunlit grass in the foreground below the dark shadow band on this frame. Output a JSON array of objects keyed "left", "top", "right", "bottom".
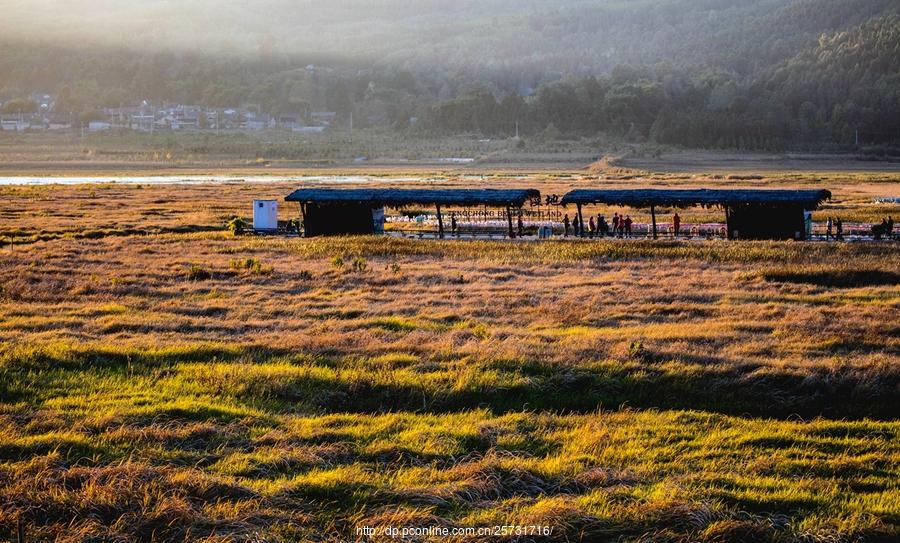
[{"left": 0, "top": 405, "right": 900, "bottom": 540}]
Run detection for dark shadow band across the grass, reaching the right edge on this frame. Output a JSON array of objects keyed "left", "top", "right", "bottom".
[{"left": 304, "top": 354, "right": 900, "bottom": 420}]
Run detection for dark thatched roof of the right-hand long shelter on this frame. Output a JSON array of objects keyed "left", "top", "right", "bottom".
[{"left": 561, "top": 189, "right": 831, "bottom": 209}]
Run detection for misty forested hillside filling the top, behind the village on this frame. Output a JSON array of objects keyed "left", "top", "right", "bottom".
[{"left": 0, "top": 0, "right": 900, "bottom": 149}]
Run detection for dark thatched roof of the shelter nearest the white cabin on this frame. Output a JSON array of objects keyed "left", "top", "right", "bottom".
[{"left": 285, "top": 188, "right": 541, "bottom": 207}]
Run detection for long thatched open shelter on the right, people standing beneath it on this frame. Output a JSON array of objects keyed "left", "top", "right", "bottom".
[{"left": 561, "top": 189, "right": 831, "bottom": 239}]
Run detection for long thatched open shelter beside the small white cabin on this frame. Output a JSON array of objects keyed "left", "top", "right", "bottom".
[{"left": 285, "top": 188, "right": 541, "bottom": 238}]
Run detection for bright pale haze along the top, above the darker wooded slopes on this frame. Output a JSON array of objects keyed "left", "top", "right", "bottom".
[{"left": 0, "top": 0, "right": 897, "bottom": 75}]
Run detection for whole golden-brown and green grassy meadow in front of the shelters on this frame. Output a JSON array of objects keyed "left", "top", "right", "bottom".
[{"left": 0, "top": 179, "right": 900, "bottom": 543}]
